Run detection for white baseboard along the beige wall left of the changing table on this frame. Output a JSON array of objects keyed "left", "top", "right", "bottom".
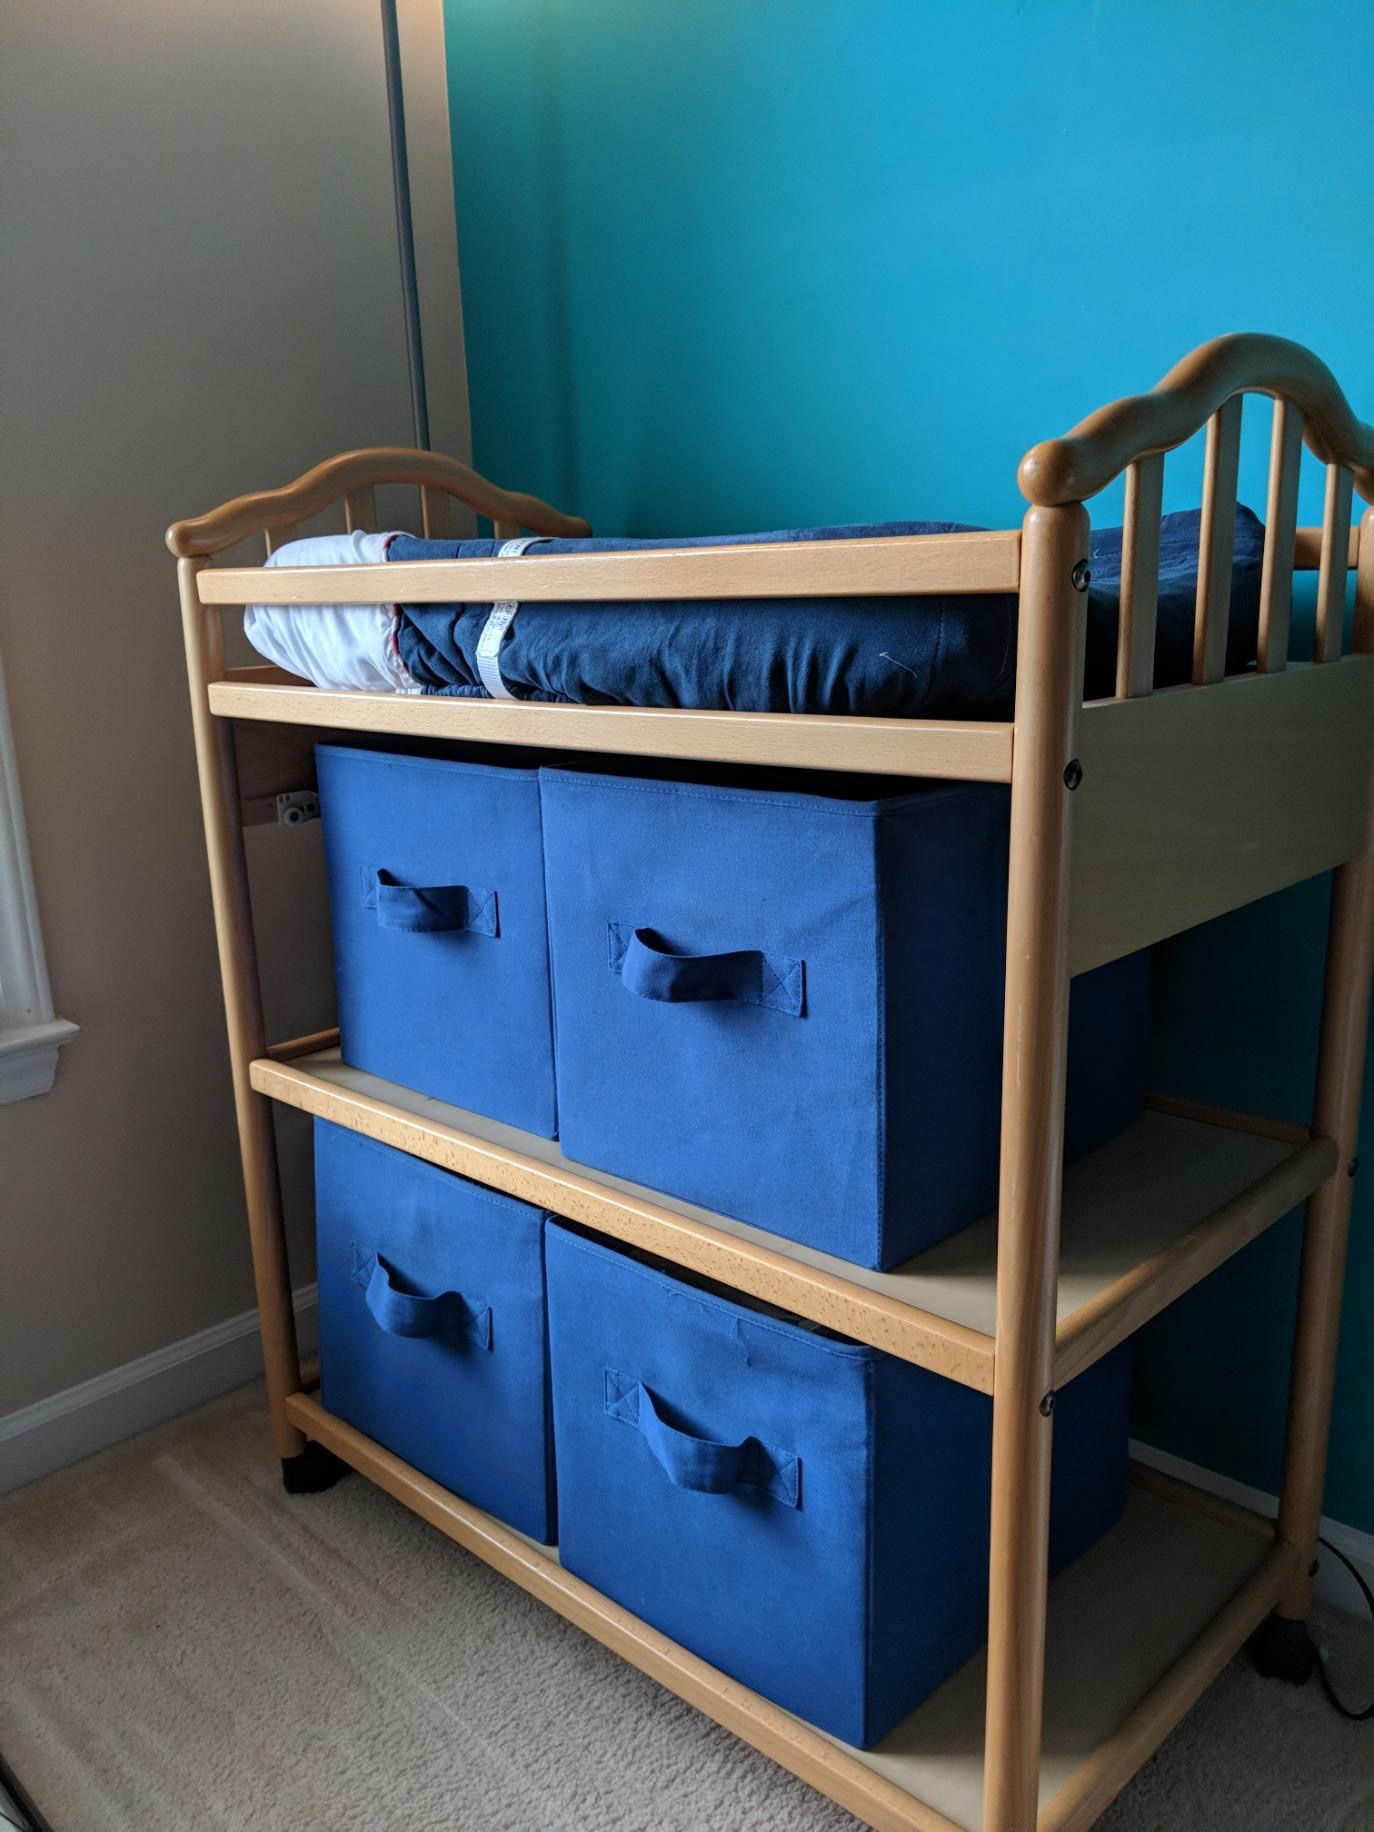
[{"left": 0, "top": 1284, "right": 317, "bottom": 1493}]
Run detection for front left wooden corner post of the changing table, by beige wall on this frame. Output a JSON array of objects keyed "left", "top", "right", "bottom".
[{"left": 176, "top": 559, "right": 306, "bottom": 1460}]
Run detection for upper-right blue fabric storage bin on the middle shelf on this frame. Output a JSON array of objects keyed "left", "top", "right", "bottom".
[{"left": 540, "top": 769, "right": 1147, "bottom": 1268}]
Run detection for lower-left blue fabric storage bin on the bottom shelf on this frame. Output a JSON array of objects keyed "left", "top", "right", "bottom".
[{"left": 315, "top": 1119, "right": 555, "bottom": 1541}]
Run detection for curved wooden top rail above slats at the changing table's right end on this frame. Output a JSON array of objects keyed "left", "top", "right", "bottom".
[{"left": 1017, "top": 332, "right": 1374, "bottom": 504}]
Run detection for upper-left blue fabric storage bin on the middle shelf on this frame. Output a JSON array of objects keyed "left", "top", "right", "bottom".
[{"left": 315, "top": 744, "right": 557, "bottom": 1138}]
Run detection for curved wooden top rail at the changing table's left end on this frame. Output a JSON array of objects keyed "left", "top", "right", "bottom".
[{"left": 167, "top": 445, "right": 592, "bottom": 559}]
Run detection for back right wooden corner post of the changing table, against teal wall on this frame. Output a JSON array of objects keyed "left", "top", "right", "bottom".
[{"left": 1279, "top": 509, "right": 1374, "bottom": 1619}]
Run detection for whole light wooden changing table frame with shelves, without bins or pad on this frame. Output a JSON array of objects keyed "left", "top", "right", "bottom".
[{"left": 167, "top": 335, "right": 1374, "bottom": 1832}]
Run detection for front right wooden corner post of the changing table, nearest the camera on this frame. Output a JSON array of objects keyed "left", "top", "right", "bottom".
[{"left": 984, "top": 504, "right": 1088, "bottom": 1832}]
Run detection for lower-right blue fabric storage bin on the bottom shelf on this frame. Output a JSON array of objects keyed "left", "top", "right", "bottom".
[{"left": 546, "top": 1224, "right": 1130, "bottom": 1746}]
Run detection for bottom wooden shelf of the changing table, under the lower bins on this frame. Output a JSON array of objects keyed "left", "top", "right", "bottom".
[{"left": 288, "top": 1392, "right": 1297, "bottom": 1832}]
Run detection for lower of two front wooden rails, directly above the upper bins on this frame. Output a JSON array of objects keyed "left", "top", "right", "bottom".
[{"left": 207, "top": 681, "right": 1013, "bottom": 782}]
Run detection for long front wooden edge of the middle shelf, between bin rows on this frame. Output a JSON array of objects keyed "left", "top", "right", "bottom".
[{"left": 249, "top": 1057, "right": 993, "bottom": 1394}]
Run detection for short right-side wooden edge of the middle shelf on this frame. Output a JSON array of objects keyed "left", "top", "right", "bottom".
[{"left": 1053, "top": 1140, "right": 1339, "bottom": 1387}]
